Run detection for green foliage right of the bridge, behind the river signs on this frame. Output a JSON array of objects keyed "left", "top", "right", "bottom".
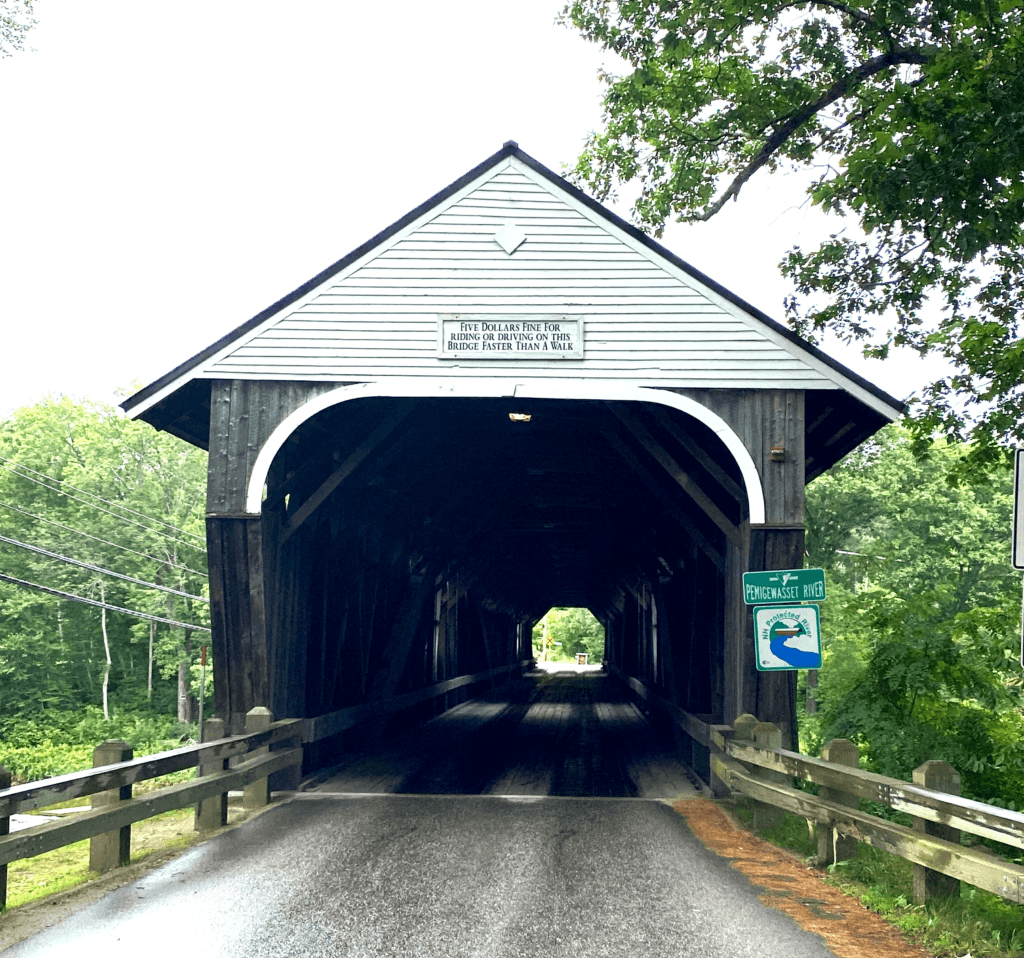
[{"left": 801, "top": 427, "right": 1024, "bottom": 807}]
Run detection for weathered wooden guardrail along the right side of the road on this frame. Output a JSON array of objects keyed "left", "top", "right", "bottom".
[{"left": 611, "top": 669, "right": 1024, "bottom": 904}]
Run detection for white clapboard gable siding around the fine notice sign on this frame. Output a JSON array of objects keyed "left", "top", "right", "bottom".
[{"left": 200, "top": 158, "right": 834, "bottom": 389}]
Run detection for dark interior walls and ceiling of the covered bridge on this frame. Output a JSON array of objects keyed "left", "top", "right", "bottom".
[{"left": 254, "top": 399, "right": 745, "bottom": 736}]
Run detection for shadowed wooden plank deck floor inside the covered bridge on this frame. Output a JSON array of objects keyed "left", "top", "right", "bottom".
[{"left": 313, "top": 670, "right": 694, "bottom": 798}]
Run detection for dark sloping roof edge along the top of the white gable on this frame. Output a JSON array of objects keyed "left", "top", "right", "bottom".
[{"left": 121, "top": 140, "right": 906, "bottom": 413}]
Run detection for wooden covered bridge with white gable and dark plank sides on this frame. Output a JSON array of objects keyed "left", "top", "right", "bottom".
[{"left": 123, "top": 142, "right": 902, "bottom": 786}]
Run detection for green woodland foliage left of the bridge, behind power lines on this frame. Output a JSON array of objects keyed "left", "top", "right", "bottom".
[{"left": 0, "top": 397, "right": 209, "bottom": 724}]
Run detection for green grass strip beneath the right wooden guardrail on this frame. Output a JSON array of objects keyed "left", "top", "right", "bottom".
[{"left": 734, "top": 805, "right": 1024, "bottom": 958}]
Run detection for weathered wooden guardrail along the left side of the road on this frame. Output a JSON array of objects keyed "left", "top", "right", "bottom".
[{"left": 0, "top": 662, "right": 528, "bottom": 908}]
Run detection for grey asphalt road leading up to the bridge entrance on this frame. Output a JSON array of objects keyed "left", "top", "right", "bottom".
[{"left": 0, "top": 794, "right": 831, "bottom": 958}]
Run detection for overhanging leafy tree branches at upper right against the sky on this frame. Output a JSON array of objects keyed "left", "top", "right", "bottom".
[{"left": 562, "top": 0, "right": 1024, "bottom": 465}]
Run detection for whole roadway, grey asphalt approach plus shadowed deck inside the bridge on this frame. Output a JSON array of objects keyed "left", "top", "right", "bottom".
[{"left": 0, "top": 672, "right": 831, "bottom": 958}]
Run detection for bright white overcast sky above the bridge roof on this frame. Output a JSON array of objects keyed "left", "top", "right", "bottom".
[{"left": 0, "top": 0, "right": 942, "bottom": 415}]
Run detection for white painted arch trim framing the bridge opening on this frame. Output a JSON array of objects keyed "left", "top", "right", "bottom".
[{"left": 246, "top": 379, "right": 765, "bottom": 525}]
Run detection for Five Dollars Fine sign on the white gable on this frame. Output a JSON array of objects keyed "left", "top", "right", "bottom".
[{"left": 437, "top": 315, "right": 583, "bottom": 359}]
